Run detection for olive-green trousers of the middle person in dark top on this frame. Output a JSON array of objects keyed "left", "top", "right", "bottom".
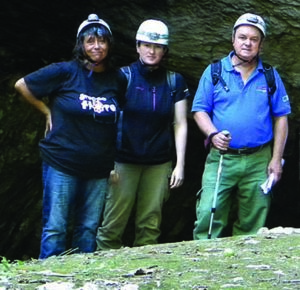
[{"left": 96, "top": 162, "right": 171, "bottom": 250}]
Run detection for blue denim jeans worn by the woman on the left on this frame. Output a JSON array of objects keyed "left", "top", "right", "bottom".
[{"left": 40, "top": 163, "right": 107, "bottom": 259}]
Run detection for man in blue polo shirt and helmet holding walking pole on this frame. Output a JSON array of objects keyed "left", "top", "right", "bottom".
[{"left": 192, "top": 13, "right": 291, "bottom": 239}]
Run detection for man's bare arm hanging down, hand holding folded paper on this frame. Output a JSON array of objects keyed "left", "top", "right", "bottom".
[{"left": 268, "top": 116, "right": 288, "bottom": 182}]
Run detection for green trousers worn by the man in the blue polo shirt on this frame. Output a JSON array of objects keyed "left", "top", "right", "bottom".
[{"left": 194, "top": 146, "right": 271, "bottom": 240}]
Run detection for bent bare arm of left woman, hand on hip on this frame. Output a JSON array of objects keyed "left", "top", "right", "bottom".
[{"left": 15, "top": 78, "right": 52, "bottom": 135}]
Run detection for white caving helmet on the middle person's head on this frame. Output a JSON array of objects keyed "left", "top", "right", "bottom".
[{"left": 136, "top": 19, "right": 169, "bottom": 45}]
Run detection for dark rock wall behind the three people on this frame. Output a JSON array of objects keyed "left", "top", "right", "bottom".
[{"left": 0, "top": 0, "right": 300, "bottom": 259}]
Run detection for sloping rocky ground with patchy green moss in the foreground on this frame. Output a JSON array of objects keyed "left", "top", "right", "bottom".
[{"left": 0, "top": 228, "right": 300, "bottom": 290}]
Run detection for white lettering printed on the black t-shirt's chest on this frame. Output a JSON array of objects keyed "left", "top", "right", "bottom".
[{"left": 79, "top": 94, "right": 117, "bottom": 113}]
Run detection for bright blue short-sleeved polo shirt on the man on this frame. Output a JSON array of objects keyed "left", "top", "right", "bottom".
[{"left": 192, "top": 52, "right": 291, "bottom": 148}]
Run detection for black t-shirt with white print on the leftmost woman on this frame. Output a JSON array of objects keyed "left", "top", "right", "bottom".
[{"left": 24, "top": 61, "right": 127, "bottom": 178}]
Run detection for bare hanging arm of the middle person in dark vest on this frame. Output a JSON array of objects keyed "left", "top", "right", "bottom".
[{"left": 170, "top": 100, "right": 187, "bottom": 188}]
